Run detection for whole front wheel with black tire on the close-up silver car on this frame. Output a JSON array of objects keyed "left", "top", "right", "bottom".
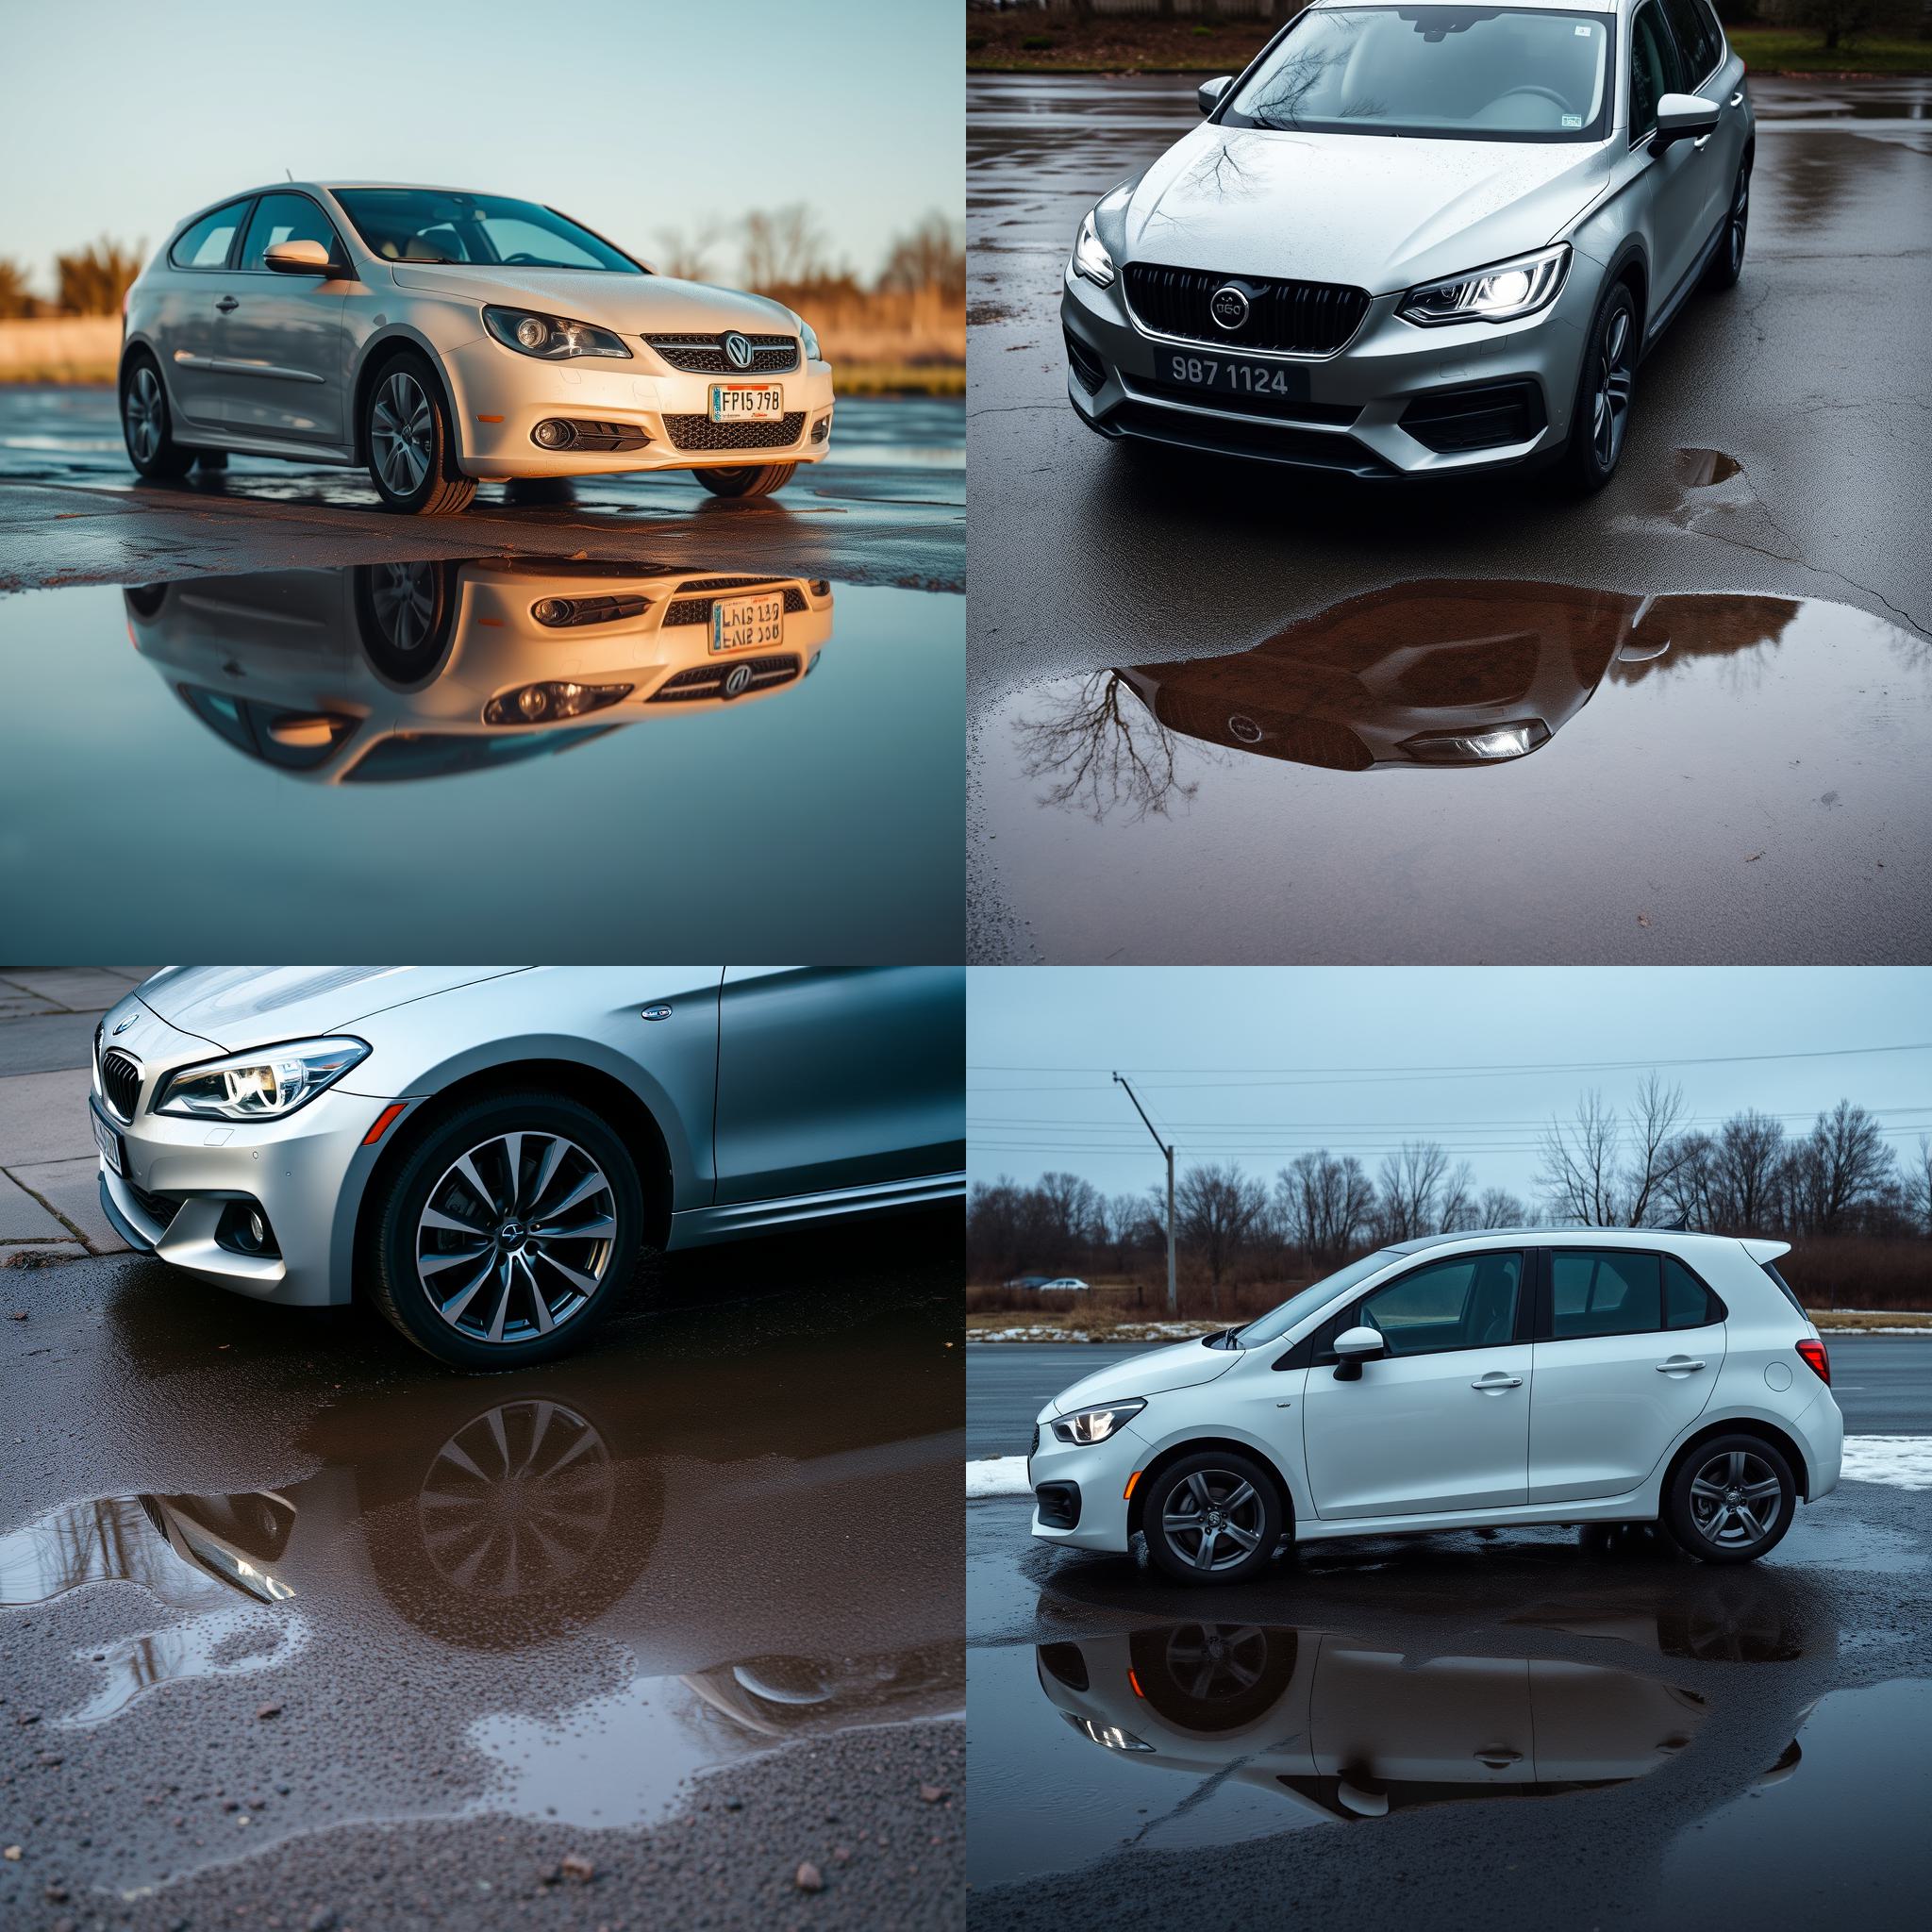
[{"left": 367, "top": 1090, "right": 643, "bottom": 1372}]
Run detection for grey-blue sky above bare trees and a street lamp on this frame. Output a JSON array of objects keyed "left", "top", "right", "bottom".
[{"left": 966, "top": 966, "right": 1932, "bottom": 1202}]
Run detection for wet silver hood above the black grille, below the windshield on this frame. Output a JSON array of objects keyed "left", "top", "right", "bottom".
[{"left": 1123, "top": 124, "right": 1609, "bottom": 295}]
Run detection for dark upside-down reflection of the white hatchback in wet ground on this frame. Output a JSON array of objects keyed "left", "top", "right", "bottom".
[{"left": 1038, "top": 1623, "right": 1803, "bottom": 1820}]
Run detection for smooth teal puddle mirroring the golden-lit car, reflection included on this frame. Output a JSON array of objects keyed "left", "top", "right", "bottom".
[{"left": 0, "top": 558, "right": 964, "bottom": 962}]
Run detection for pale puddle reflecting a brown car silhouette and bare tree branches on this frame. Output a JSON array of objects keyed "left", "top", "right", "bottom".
[{"left": 974, "top": 575, "right": 1932, "bottom": 962}]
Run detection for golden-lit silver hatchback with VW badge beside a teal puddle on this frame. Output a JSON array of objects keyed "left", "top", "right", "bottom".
[{"left": 120, "top": 182, "right": 833, "bottom": 512}]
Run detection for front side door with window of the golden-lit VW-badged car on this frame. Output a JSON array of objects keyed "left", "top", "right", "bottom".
[{"left": 218, "top": 193, "right": 348, "bottom": 444}]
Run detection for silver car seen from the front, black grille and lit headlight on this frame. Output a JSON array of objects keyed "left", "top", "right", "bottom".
[{"left": 1060, "top": 0, "right": 1755, "bottom": 491}]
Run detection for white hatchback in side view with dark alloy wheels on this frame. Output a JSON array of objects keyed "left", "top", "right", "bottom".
[{"left": 1028, "top": 1229, "right": 1845, "bottom": 1582}]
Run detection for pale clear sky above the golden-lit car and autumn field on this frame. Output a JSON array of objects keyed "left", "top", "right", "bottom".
[{"left": 0, "top": 0, "right": 966, "bottom": 293}]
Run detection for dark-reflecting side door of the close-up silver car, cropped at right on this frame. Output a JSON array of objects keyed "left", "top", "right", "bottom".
[{"left": 717, "top": 966, "right": 966, "bottom": 1204}]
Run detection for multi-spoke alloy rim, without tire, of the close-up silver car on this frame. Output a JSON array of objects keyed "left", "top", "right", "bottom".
[{"left": 415, "top": 1132, "right": 616, "bottom": 1344}]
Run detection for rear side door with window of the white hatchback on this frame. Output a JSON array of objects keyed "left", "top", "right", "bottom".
[{"left": 1530, "top": 1246, "right": 1725, "bottom": 1503}]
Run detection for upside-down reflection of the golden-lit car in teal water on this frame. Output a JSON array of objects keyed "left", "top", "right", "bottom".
[{"left": 125, "top": 558, "right": 833, "bottom": 784}]
